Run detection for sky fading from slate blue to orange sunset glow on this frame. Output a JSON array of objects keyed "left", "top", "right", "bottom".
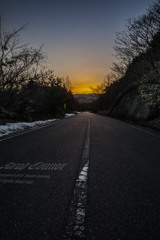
[{"left": 0, "top": 0, "right": 154, "bottom": 93}]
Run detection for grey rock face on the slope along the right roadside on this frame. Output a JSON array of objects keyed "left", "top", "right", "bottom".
[{"left": 111, "top": 83, "right": 160, "bottom": 121}]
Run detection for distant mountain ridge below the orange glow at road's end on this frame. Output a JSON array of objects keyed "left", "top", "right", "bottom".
[{"left": 74, "top": 94, "right": 98, "bottom": 104}]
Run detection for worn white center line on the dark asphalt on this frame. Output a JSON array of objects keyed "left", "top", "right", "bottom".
[{"left": 64, "top": 119, "right": 90, "bottom": 239}]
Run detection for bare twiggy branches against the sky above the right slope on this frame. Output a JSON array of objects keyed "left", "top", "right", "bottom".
[{"left": 111, "top": 0, "right": 160, "bottom": 77}]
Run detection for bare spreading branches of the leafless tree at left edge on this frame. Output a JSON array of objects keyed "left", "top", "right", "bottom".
[{"left": 0, "top": 17, "right": 45, "bottom": 106}]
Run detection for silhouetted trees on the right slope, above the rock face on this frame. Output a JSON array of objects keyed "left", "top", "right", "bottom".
[{"left": 95, "top": 0, "right": 160, "bottom": 110}]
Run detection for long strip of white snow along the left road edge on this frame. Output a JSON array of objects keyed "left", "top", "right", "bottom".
[{"left": 0, "top": 119, "right": 56, "bottom": 137}]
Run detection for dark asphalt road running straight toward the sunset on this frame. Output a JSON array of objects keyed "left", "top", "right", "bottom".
[{"left": 0, "top": 113, "right": 160, "bottom": 240}]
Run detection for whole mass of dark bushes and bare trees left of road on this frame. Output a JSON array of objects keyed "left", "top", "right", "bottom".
[{"left": 0, "top": 19, "right": 75, "bottom": 124}]
